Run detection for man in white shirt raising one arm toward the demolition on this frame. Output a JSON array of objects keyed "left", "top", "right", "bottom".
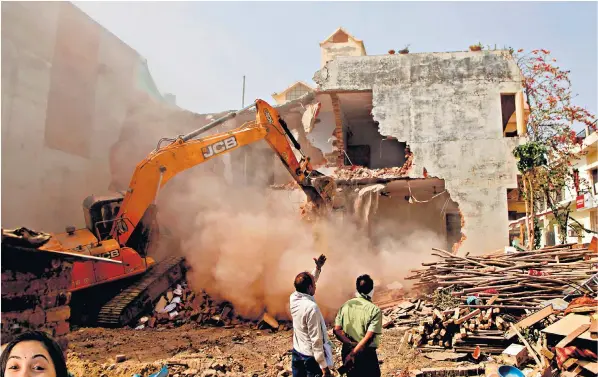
[{"left": 290, "top": 255, "right": 332, "bottom": 377}]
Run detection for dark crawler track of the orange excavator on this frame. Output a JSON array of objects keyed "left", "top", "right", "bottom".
[{"left": 97, "top": 257, "right": 185, "bottom": 327}]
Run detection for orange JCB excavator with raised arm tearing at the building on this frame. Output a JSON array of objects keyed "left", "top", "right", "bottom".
[{"left": 18, "top": 99, "right": 336, "bottom": 327}]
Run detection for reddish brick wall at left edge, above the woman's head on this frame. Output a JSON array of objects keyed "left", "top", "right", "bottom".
[{"left": 2, "top": 245, "right": 72, "bottom": 349}]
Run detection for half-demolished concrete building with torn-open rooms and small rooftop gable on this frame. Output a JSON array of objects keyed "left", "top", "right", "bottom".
[{"left": 264, "top": 28, "right": 526, "bottom": 253}]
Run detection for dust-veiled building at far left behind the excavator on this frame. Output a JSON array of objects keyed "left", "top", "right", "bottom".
[{"left": 2, "top": 2, "right": 223, "bottom": 231}]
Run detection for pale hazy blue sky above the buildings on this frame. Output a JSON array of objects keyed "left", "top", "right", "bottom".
[{"left": 75, "top": 1, "right": 598, "bottom": 119}]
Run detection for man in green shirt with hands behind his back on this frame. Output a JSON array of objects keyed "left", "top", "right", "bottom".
[{"left": 334, "top": 275, "right": 382, "bottom": 377}]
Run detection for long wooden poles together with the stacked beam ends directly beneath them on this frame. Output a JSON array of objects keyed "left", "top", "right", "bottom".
[{"left": 407, "top": 245, "right": 598, "bottom": 354}]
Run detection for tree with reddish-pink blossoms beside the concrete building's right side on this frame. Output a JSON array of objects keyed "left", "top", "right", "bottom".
[{"left": 513, "top": 49, "right": 596, "bottom": 249}]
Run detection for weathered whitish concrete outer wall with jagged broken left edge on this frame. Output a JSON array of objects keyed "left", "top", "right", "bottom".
[{"left": 314, "top": 51, "right": 521, "bottom": 253}]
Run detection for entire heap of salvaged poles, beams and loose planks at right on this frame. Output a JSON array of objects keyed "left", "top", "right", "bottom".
[{"left": 383, "top": 245, "right": 598, "bottom": 374}]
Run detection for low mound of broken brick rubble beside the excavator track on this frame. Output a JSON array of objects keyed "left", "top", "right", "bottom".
[{"left": 135, "top": 282, "right": 289, "bottom": 330}]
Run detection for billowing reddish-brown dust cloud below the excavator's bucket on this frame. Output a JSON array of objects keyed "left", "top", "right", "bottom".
[{"left": 159, "top": 168, "right": 444, "bottom": 319}]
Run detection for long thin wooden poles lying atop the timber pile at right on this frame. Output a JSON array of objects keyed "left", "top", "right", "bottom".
[{"left": 407, "top": 245, "right": 598, "bottom": 311}]
